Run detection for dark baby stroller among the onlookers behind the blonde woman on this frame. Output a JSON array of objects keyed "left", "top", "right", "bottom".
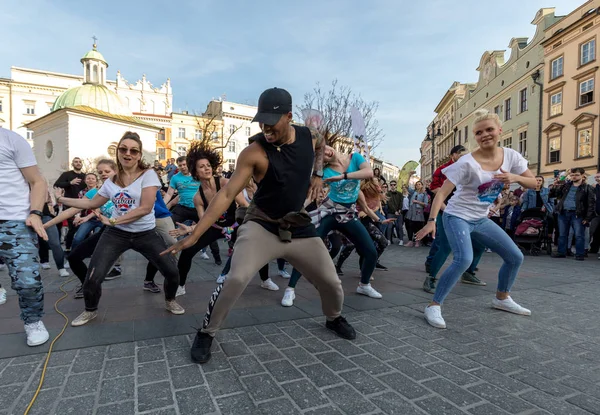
[{"left": 514, "top": 208, "right": 552, "bottom": 256}]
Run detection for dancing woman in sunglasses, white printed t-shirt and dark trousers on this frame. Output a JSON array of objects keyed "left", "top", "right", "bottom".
[{"left": 58, "top": 132, "right": 185, "bottom": 326}]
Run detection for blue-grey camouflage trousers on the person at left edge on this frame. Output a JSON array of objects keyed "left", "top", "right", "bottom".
[{"left": 0, "top": 220, "right": 44, "bottom": 324}]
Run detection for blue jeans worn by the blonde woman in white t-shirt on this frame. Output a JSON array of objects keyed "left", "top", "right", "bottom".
[{"left": 433, "top": 213, "right": 523, "bottom": 304}]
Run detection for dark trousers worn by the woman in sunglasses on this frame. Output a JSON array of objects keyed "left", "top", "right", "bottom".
[{"left": 81, "top": 228, "right": 179, "bottom": 311}]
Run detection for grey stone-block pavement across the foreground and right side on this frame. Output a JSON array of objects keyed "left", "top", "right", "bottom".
[{"left": 0, "top": 242, "right": 600, "bottom": 415}]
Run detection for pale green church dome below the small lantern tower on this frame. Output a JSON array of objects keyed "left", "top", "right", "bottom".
[{"left": 51, "top": 84, "right": 131, "bottom": 115}]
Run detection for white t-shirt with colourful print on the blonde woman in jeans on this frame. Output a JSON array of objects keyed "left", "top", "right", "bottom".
[{"left": 443, "top": 148, "right": 527, "bottom": 221}]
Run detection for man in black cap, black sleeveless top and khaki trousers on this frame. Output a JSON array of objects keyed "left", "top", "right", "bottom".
[{"left": 164, "top": 88, "right": 356, "bottom": 363}]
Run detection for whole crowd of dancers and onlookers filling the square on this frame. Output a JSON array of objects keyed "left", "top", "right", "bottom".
[{"left": 0, "top": 88, "right": 600, "bottom": 363}]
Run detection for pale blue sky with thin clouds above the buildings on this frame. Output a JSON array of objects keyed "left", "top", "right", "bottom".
[{"left": 0, "top": 0, "right": 583, "bottom": 166}]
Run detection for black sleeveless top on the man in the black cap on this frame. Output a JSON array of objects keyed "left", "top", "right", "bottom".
[{"left": 252, "top": 125, "right": 317, "bottom": 238}]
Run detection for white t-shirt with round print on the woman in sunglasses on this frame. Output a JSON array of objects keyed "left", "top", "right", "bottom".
[{"left": 98, "top": 169, "right": 160, "bottom": 232}]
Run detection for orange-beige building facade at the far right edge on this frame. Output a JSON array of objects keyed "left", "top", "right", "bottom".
[{"left": 541, "top": 0, "right": 600, "bottom": 177}]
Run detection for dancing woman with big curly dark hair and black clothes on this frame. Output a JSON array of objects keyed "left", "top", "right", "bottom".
[{"left": 166, "top": 141, "right": 248, "bottom": 295}]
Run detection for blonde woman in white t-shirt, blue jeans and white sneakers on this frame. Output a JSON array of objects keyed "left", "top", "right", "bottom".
[{"left": 417, "top": 109, "right": 536, "bottom": 328}]
